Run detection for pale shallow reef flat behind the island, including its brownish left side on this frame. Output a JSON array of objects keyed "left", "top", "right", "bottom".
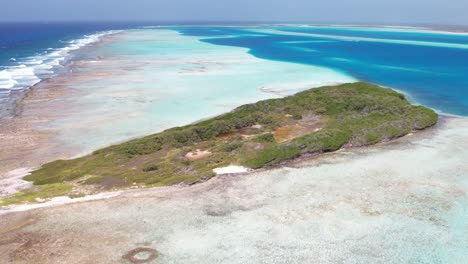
[{"left": 0, "top": 29, "right": 356, "bottom": 184}]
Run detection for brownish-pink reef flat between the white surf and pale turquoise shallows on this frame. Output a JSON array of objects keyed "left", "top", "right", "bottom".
[{"left": 0, "top": 33, "right": 124, "bottom": 174}]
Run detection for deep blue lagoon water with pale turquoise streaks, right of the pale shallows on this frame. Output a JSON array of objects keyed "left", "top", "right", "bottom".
[{"left": 175, "top": 26, "right": 468, "bottom": 116}]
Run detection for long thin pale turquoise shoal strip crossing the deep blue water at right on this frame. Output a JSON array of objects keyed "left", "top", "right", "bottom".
[{"left": 248, "top": 29, "right": 468, "bottom": 49}]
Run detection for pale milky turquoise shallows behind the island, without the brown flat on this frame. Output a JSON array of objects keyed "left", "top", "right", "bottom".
[{"left": 43, "top": 29, "right": 355, "bottom": 153}]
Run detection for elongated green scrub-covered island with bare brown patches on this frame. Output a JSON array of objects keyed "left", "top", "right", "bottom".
[{"left": 0, "top": 82, "right": 438, "bottom": 206}]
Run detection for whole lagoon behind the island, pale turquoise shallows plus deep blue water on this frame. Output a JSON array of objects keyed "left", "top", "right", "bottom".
[{"left": 45, "top": 25, "right": 468, "bottom": 153}]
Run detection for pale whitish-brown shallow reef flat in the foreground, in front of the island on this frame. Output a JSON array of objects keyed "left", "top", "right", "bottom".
[{"left": 0, "top": 117, "right": 468, "bottom": 263}]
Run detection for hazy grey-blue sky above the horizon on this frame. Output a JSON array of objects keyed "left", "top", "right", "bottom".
[{"left": 0, "top": 0, "right": 468, "bottom": 25}]
